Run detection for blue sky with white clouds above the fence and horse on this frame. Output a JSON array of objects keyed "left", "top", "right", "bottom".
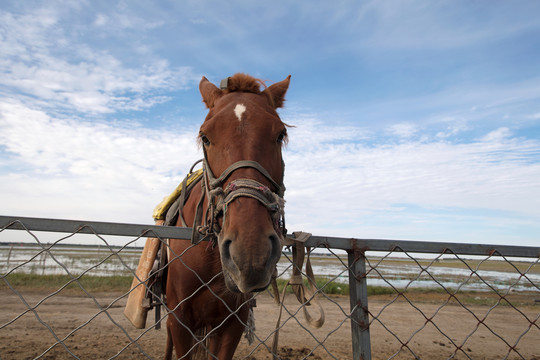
[{"left": 0, "top": 0, "right": 540, "bottom": 246}]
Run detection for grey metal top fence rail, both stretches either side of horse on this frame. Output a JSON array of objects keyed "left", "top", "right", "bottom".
[{"left": 0, "top": 215, "right": 540, "bottom": 258}]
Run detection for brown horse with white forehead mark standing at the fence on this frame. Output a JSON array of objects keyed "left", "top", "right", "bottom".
[{"left": 165, "top": 74, "right": 290, "bottom": 359}]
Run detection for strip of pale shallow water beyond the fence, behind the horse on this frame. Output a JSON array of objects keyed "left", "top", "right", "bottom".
[{"left": 0, "top": 245, "right": 540, "bottom": 292}]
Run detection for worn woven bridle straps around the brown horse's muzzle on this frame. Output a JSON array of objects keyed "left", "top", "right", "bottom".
[{"left": 191, "top": 147, "right": 287, "bottom": 246}]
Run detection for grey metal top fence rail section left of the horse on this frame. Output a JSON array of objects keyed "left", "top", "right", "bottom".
[{"left": 0, "top": 215, "right": 191, "bottom": 239}]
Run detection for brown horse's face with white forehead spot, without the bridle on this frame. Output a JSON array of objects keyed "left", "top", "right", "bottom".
[{"left": 200, "top": 74, "right": 290, "bottom": 293}]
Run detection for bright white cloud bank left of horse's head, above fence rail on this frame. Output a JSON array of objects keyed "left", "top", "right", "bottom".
[{"left": 0, "top": 102, "right": 200, "bottom": 223}]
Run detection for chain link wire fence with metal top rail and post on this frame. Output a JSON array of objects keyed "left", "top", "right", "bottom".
[{"left": 0, "top": 216, "right": 540, "bottom": 359}]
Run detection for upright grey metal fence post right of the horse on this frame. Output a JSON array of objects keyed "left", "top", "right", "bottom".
[{"left": 348, "top": 246, "right": 371, "bottom": 360}]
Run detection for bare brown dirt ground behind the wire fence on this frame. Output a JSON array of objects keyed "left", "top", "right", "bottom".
[{"left": 0, "top": 290, "right": 540, "bottom": 360}]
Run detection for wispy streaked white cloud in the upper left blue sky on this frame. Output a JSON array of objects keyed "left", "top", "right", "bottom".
[{"left": 0, "top": 4, "right": 198, "bottom": 113}]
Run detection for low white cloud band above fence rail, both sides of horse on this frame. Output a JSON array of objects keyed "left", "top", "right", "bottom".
[{"left": 0, "top": 101, "right": 540, "bottom": 246}]
